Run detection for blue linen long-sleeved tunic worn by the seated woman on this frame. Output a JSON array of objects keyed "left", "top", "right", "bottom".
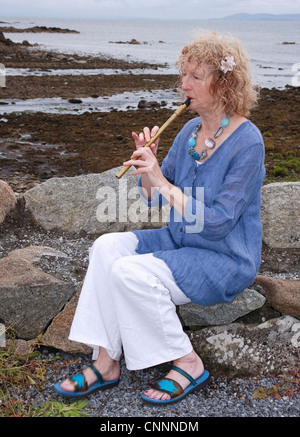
[{"left": 133, "top": 117, "right": 265, "bottom": 305}]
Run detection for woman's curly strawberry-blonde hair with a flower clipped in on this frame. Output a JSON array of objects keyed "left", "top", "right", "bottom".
[{"left": 177, "top": 32, "right": 259, "bottom": 117}]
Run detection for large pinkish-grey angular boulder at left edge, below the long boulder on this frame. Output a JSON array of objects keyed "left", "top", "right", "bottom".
[{"left": 0, "top": 246, "right": 74, "bottom": 340}]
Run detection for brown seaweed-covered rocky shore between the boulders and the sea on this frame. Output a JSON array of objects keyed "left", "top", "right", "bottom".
[{"left": 0, "top": 34, "right": 300, "bottom": 192}]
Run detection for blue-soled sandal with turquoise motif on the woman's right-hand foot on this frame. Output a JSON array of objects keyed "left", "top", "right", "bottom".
[{"left": 142, "top": 366, "right": 210, "bottom": 405}]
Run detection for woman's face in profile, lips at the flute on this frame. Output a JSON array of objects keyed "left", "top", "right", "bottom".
[{"left": 181, "top": 62, "right": 214, "bottom": 114}]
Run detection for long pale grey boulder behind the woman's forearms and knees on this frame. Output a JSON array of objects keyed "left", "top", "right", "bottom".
[{"left": 24, "top": 167, "right": 166, "bottom": 235}]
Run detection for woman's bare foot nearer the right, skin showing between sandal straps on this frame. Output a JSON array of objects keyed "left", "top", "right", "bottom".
[{"left": 144, "top": 351, "right": 204, "bottom": 400}]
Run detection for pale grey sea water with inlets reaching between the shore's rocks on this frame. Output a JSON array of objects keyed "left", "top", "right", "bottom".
[{"left": 0, "top": 17, "right": 300, "bottom": 113}]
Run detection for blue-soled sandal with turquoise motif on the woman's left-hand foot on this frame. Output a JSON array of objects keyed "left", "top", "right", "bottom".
[{"left": 53, "top": 364, "right": 120, "bottom": 398}]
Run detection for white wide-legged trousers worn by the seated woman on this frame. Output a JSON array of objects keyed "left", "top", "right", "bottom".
[{"left": 69, "top": 232, "right": 193, "bottom": 370}]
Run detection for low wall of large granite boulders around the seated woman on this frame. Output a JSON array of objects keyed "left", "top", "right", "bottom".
[{"left": 0, "top": 174, "right": 300, "bottom": 375}]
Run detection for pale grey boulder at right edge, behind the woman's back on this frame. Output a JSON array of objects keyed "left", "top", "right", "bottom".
[{"left": 261, "top": 182, "right": 300, "bottom": 248}]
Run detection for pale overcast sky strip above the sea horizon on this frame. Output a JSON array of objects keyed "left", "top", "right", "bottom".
[{"left": 0, "top": 0, "right": 300, "bottom": 21}]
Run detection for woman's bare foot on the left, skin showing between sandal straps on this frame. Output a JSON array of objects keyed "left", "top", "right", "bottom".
[{"left": 60, "top": 348, "right": 120, "bottom": 392}]
